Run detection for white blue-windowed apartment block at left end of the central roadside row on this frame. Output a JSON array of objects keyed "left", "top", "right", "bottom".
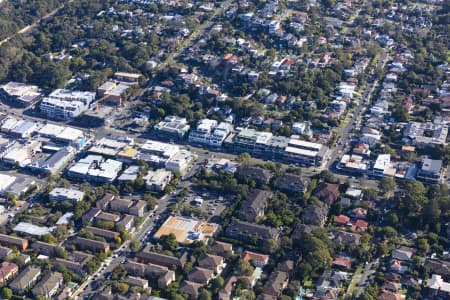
[{"left": 189, "top": 119, "right": 233, "bottom": 147}]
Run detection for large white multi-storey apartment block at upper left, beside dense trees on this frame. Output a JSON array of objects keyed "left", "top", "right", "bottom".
[{"left": 40, "top": 89, "right": 95, "bottom": 120}]
